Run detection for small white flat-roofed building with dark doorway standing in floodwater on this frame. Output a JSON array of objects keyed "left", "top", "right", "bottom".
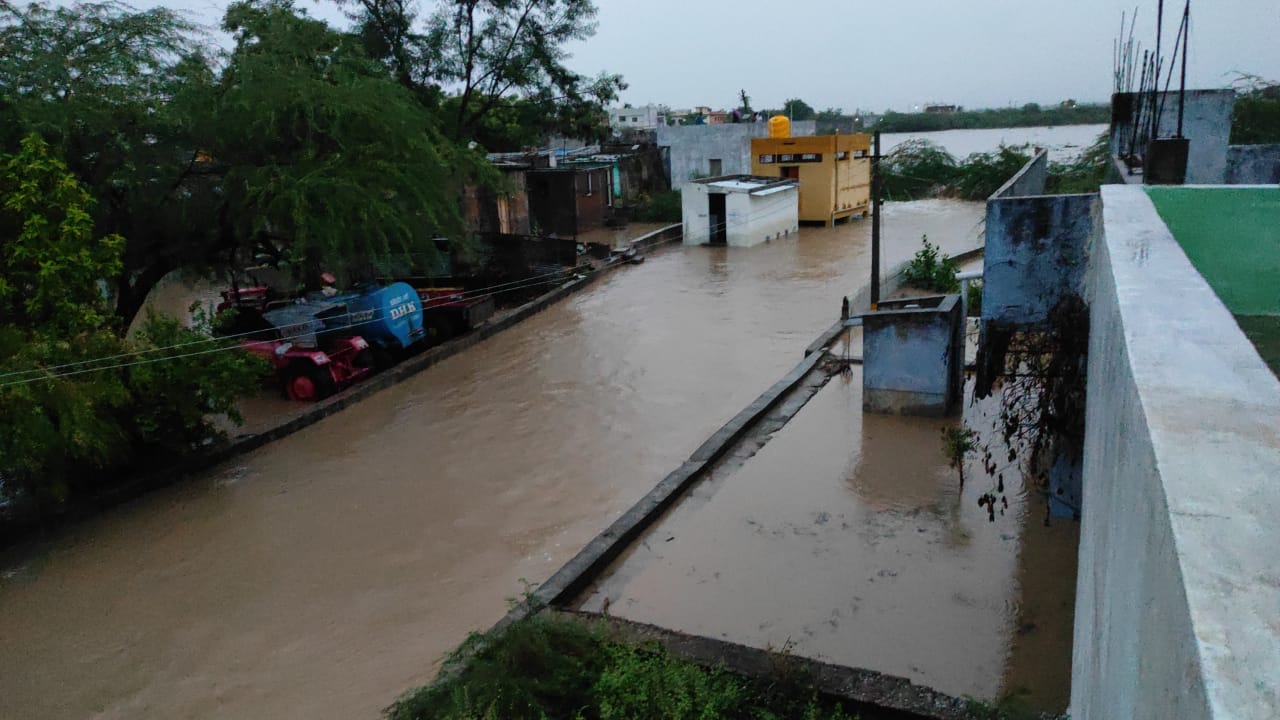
[{"left": 680, "top": 176, "right": 800, "bottom": 247}]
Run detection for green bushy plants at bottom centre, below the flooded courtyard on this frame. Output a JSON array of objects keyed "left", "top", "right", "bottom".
[{"left": 388, "top": 614, "right": 858, "bottom": 720}]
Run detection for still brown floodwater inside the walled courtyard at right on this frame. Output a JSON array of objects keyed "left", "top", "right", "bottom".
[{"left": 580, "top": 371, "right": 1078, "bottom": 711}]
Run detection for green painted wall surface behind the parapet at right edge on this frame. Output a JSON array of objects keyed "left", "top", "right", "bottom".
[{"left": 1147, "top": 186, "right": 1280, "bottom": 315}]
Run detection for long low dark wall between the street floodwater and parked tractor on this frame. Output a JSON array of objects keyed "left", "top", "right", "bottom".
[{"left": 0, "top": 223, "right": 682, "bottom": 548}]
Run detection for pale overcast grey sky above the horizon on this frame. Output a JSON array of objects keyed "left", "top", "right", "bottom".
[{"left": 160, "top": 0, "right": 1280, "bottom": 111}]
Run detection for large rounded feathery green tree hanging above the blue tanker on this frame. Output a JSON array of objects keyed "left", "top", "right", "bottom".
[{"left": 197, "top": 1, "right": 493, "bottom": 284}]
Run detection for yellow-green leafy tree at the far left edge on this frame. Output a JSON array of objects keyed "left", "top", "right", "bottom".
[{"left": 0, "top": 135, "right": 259, "bottom": 509}]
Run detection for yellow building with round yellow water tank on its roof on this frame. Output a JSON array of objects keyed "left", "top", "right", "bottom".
[{"left": 751, "top": 118, "right": 872, "bottom": 225}]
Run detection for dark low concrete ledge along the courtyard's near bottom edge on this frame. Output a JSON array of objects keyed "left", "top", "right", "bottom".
[{"left": 556, "top": 611, "right": 969, "bottom": 720}]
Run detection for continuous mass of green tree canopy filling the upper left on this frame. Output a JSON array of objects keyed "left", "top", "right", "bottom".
[{"left": 0, "top": 0, "right": 622, "bottom": 509}]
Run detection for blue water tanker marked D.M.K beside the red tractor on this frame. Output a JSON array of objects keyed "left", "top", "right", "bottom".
[{"left": 317, "top": 282, "right": 426, "bottom": 365}]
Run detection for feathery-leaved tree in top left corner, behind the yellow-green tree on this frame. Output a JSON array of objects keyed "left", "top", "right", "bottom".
[{"left": 0, "top": 3, "right": 217, "bottom": 325}]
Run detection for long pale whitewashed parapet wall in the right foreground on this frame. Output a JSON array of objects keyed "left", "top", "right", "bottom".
[{"left": 1071, "top": 186, "right": 1280, "bottom": 720}]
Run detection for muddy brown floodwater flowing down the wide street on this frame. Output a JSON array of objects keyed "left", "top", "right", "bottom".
[{"left": 0, "top": 201, "right": 983, "bottom": 719}]
